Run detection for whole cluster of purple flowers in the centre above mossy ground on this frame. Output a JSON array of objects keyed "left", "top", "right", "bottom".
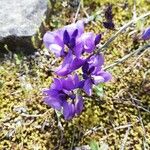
[{"left": 43, "top": 21, "right": 111, "bottom": 120}]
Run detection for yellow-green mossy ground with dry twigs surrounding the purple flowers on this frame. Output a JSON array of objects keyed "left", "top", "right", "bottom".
[{"left": 0, "top": 0, "right": 150, "bottom": 150}]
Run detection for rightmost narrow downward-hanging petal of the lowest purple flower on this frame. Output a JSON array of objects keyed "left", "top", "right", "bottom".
[{"left": 75, "top": 96, "right": 83, "bottom": 115}]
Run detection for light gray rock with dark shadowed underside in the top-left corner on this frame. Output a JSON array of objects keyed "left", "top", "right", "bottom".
[{"left": 0, "top": 0, "right": 48, "bottom": 52}]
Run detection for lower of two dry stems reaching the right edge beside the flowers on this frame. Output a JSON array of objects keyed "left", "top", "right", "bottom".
[{"left": 104, "top": 44, "right": 150, "bottom": 70}]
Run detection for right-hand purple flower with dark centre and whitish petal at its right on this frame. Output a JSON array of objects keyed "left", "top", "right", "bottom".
[{"left": 82, "top": 54, "right": 111, "bottom": 95}]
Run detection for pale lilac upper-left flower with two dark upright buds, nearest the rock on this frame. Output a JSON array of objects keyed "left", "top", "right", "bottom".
[{"left": 43, "top": 21, "right": 84, "bottom": 57}]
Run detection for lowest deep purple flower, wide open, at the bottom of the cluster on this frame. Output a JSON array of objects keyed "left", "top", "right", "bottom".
[{"left": 44, "top": 75, "right": 83, "bottom": 120}]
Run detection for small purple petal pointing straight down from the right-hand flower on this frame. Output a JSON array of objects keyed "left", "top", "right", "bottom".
[{"left": 83, "top": 79, "right": 92, "bottom": 96}]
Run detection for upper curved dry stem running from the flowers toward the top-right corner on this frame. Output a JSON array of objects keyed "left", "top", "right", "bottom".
[{"left": 98, "top": 12, "right": 150, "bottom": 51}]
